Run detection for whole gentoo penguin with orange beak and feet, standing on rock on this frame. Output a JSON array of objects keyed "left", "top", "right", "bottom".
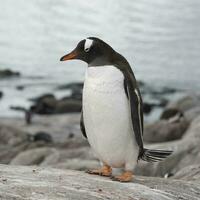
[{"left": 60, "top": 37, "right": 172, "bottom": 182}]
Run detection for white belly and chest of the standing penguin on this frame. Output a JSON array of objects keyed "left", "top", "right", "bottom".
[{"left": 83, "top": 66, "right": 138, "bottom": 167}]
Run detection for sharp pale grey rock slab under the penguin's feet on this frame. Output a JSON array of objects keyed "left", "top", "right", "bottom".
[{"left": 0, "top": 165, "right": 200, "bottom": 200}]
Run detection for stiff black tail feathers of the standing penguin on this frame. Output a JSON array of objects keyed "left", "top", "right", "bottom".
[{"left": 141, "top": 149, "right": 173, "bottom": 162}]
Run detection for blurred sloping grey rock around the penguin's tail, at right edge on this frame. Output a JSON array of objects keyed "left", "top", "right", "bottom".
[{"left": 135, "top": 116, "right": 200, "bottom": 177}]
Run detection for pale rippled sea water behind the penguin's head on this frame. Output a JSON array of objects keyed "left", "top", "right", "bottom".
[{"left": 0, "top": 0, "right": 200, "bottom": 116}]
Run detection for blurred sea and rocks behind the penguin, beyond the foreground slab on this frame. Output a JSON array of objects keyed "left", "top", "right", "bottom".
[{"left": 0, "top": 0, "right": 200, "bottom": 176}]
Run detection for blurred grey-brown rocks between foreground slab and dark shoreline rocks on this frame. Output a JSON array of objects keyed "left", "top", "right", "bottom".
[{"left": 0, "top": 96, "right": 200, "bottom": 173}]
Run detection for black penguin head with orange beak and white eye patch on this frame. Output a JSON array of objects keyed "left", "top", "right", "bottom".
[{"left": 60, "top": 37, "right": 114, "bottom": 66}]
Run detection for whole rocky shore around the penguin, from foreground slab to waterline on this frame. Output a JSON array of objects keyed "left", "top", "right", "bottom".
[{"left": 0, "top": 69, "right": 200, "bottom": 200}]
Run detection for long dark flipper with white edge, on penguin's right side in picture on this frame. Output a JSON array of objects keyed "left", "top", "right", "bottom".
[{"left": 124, "top": 71, "right": 144, "bottom": 159}]
